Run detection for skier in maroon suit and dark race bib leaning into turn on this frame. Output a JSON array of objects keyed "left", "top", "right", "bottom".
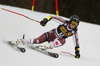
[{"left": 11, "top": 15, "right": 80, "bottom": 58}]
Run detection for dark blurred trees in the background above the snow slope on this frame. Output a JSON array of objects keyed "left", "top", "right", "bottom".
[{"left": 0, "top": 0, "right": 100, "bottom": 24}]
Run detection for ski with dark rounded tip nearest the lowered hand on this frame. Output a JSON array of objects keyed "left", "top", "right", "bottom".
[{"left": 33, "top": 46, "right": 59, "bottom": 58}]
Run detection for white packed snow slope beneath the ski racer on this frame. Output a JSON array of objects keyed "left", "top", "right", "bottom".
[{"left": 0, "top": 5, "right": 100, "bottom": 66}]
